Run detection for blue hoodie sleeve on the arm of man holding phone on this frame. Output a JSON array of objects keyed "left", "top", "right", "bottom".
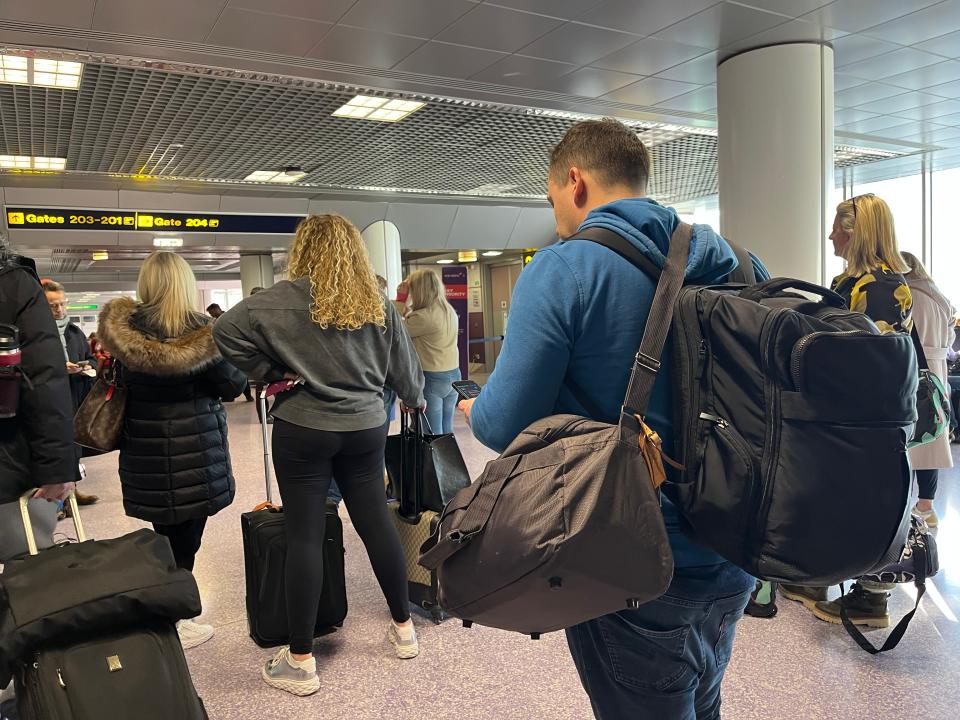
[{"left": 470, "top": 249, "right": 581, "bottom": 452}]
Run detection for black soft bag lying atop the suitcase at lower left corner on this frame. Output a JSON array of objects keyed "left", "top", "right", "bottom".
[{"left": 0, "top": 492, "right": 201, "bottom": 687}]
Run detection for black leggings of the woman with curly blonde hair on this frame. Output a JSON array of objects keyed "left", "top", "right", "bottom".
[{"left": 273, "top": 418, "right": 410, "bottom": 655}]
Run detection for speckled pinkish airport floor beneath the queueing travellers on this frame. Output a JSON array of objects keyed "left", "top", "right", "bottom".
[{"left": 62, "top": 400, "right": 960, "bottom": 720}]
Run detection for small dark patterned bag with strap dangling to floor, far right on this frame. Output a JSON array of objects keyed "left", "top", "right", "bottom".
[{"left": 840, "top": 515, "right": 940, "bottom": 655}]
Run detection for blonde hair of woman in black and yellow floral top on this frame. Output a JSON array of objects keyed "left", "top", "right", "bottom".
[{"left": 837, "top": 193, "right": 910, "bottom": 277}]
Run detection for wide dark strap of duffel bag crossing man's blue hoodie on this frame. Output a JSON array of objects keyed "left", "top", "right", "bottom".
[{"left": 621, "top": 222, "right": 693, "bottom": 424}]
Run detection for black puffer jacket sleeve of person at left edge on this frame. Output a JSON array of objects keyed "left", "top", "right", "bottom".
[{"left": 7, "top": 270, "right": 77, "bottom": 485}]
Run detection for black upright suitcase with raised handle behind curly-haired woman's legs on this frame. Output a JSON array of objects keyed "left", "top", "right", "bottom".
[{"left": 240, "top": 393, "right": 347, "bottom": 647}]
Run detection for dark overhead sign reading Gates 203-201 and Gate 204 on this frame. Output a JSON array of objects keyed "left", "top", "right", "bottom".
[{"left": 6, "top": 207, "right": 303, "bottom": 235}]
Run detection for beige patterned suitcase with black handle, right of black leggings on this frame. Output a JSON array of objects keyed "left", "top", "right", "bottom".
[{"left": 387, "top": 411, "right": 445, "bottom": 623}]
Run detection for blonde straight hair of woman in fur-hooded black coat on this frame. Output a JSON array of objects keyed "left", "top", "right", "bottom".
[{"left": 137, "top": 251, "right": 197, "bottom": 337}]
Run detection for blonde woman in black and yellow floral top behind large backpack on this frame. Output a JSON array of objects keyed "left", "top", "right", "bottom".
[{"left": 780, "top": 194, "right": 913, "bottom": 627}]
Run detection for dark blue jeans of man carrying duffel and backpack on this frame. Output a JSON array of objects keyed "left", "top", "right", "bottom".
[{"left": 567, "top": 563, "right": 754, "bottom": 720}]
